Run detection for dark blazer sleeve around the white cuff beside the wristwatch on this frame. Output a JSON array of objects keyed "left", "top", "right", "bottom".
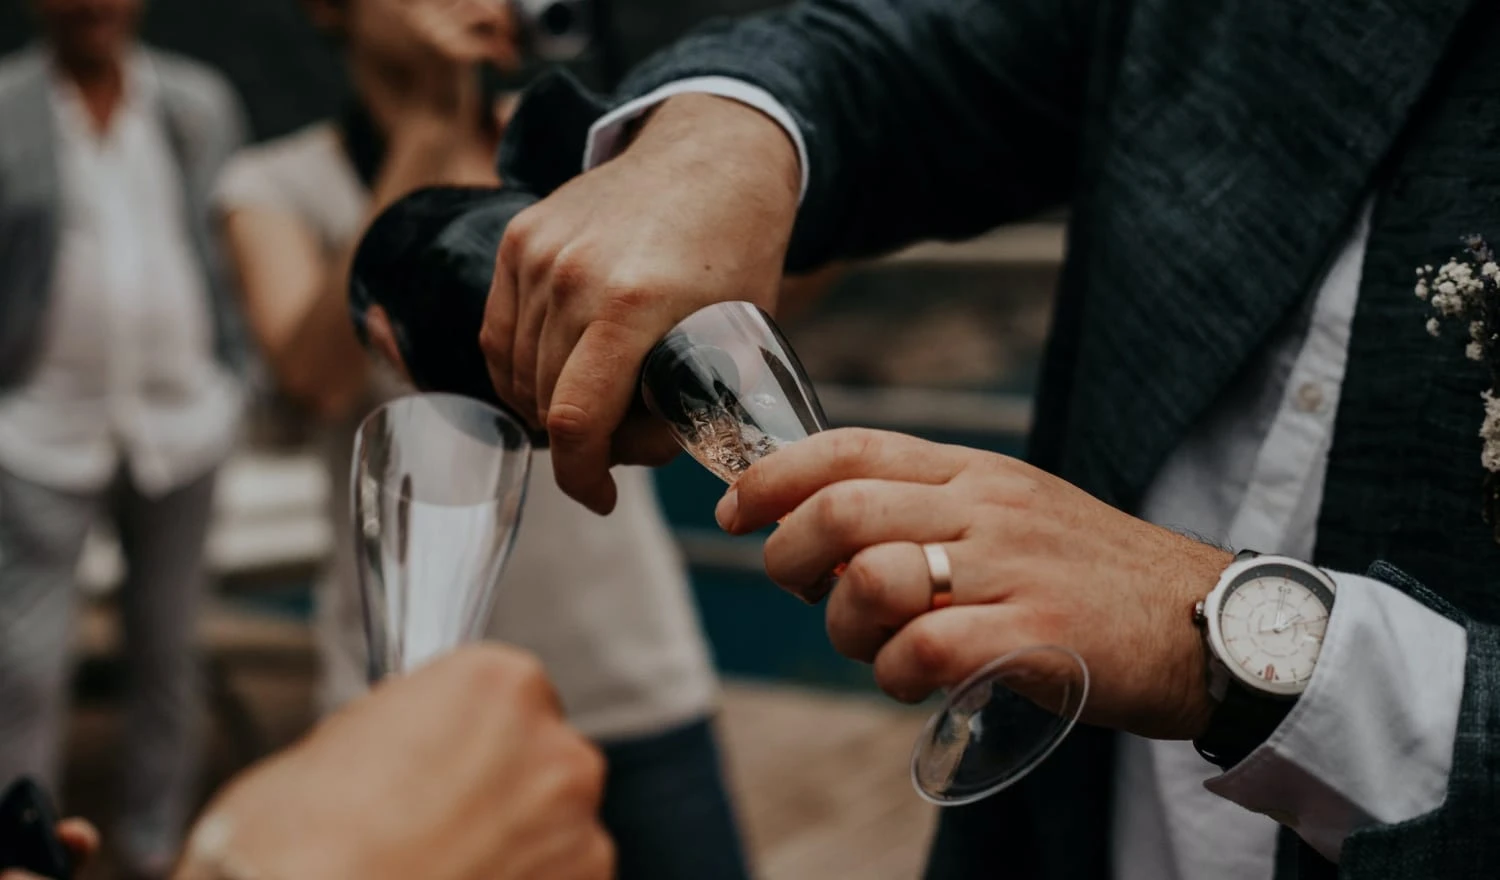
[{"left": 1338, "top": 564, "right": 1500, "bottom": 880}]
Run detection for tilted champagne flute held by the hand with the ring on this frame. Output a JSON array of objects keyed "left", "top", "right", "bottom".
[{"left": 641, "top": 303, "right": 1089, "bottom": 807}]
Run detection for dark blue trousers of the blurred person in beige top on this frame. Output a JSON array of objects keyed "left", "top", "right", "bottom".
[{"left": 602, "top": 721, "right": 750, "bottom": 880}]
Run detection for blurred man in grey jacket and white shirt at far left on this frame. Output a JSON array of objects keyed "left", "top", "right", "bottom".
[{"left": 0, "top": 0, "right": 243, "bottom": 877}]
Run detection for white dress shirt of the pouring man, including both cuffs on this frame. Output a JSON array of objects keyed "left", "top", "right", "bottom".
[{"left": 585, "top": 78, "right": 1467, "bottom": 880}]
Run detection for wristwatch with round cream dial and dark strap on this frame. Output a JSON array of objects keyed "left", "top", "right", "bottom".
[{"left": 1193, "top": 550, "right": 1335, "bottom": 769}]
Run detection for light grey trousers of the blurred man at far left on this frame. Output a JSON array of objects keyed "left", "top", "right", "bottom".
[{"left": 0, "top": 469, "right": 213, "bottom": 870}]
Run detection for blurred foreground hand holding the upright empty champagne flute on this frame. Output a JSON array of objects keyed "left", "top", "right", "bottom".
[{"left": 176, "top": 645, "right": 614, "bottom": 880}]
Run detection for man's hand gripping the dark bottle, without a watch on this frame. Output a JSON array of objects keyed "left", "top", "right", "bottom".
[{"left": 480, "top": 94, "right": 801, "bottom": 513}]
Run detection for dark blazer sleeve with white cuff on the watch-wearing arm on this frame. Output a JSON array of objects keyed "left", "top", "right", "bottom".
[{"left": 1206, "top": 564, "right": 1500, "bottom": 877}]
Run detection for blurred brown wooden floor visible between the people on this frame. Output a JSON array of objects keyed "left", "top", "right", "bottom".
[{"left": 66, "top": 641, "right": 933, "bottom": 880}]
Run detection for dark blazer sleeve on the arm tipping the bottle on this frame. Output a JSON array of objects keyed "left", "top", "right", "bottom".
[{"left": 617, "top": 0, "right": 1106, "bottom": 271}]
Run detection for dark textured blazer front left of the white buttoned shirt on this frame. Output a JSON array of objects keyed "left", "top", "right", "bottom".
[{"left": 1061, "top": 0, "right": 1476, "bottom": 507}]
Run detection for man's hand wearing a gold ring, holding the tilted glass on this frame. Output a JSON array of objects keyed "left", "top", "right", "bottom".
[{"left": 717, "top": 430, "right": 1232, "bottom": 739}]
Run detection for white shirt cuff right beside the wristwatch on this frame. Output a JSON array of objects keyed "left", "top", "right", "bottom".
[{"left": 1205, "top": 573, "right": 1469, "bottom": 862}]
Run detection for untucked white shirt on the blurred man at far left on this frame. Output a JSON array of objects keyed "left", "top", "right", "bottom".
[{"left": 0, "top": 57, "right": 243, "bottom": 496}]
